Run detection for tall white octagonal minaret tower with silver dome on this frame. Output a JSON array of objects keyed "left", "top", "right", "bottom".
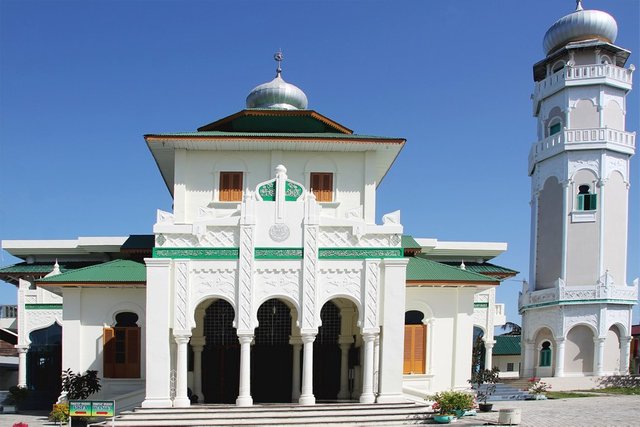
[{"left": 519, "top": 1, "right": 638, "bottom": 377}]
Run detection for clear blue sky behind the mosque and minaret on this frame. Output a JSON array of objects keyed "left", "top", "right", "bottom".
[{"left": 0, "top": 0, "right": 640, "bottom": 328}]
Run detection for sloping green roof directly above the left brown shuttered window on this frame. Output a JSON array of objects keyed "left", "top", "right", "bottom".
[{"left": 38, "top": 259, "right": 147, "bottom": 284}]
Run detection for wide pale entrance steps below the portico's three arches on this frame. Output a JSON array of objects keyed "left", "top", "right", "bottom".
[{"left": 92, "top": 402, "right": 430, "bottom": 427}]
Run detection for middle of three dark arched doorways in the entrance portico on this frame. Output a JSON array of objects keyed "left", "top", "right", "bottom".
[{"left": 251, "top": 299, "right": 292, "bottom": 403}]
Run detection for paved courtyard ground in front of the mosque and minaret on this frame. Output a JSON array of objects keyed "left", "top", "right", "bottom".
[{"left": 0, "top": 395, "right": 640, "bottom": 427}]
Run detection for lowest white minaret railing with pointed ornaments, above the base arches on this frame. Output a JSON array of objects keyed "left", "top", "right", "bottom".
[{"left": 518, "top": 274, "right": 638, "bottom": 312}]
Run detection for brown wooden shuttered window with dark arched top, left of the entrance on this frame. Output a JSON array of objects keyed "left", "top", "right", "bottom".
[{"left": 103, "top": 313, "right": 140, "bottom": 378}]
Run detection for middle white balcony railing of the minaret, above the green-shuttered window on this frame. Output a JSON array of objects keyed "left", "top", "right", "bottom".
[{"left": 529, "top": 127, "right": 636, "bottom": 173}]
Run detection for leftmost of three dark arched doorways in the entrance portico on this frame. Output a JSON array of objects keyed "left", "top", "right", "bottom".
[{"left": 202, "top": 300, "right": 240, "bottom": 403}]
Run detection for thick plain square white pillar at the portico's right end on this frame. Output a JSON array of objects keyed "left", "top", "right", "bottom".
[{"left": 377, "top": 258, "right": 409, "bottom": 403}]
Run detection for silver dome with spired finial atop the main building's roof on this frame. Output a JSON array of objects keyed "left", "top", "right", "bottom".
[{"left": 247, "top": 52, "right": 308, "bottom": 110}]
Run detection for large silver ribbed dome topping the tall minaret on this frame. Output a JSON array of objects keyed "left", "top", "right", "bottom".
[{"left": 542, "top": 0, "right": 618, "bottom": 54}]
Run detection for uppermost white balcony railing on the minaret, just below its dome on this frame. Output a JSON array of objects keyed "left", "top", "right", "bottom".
[{"left": 532, "top": 64, "right": 635, "bottom": 115}]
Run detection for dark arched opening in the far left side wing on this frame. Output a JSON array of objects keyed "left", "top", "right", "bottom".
[{"left": 24, "top": 323, "right": 62, "bottom": 409}]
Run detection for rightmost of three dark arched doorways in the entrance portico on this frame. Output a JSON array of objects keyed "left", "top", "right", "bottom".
[{"left": 313, "top": 301, "right": 341, "bottom": 400}]
